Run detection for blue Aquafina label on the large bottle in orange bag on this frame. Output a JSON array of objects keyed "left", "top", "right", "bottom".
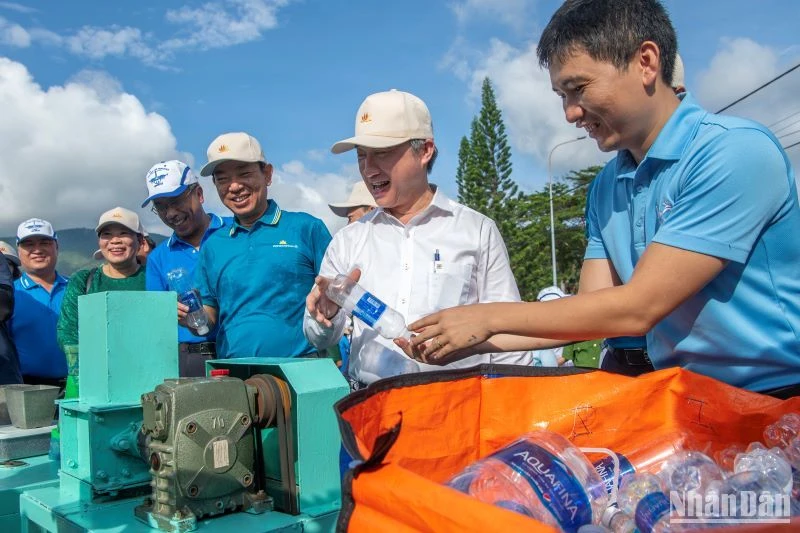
[{"left": 492, "top": 441, "right": 592, "bottom": 531}]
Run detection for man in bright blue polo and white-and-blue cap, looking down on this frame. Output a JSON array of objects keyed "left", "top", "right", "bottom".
[{"left": 142, "top": 160, "right": 230, "bottom": 377}]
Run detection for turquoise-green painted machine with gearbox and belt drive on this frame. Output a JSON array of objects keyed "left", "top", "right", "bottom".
[{"left": 20, "top": 292, "right": 349, "bottom": 533}]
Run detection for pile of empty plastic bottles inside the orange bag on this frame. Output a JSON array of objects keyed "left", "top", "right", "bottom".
[{"left": 447, "top": 413, "right": 800, "bottom": 533}]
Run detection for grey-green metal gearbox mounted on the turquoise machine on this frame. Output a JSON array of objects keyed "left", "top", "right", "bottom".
[{"left": 135, "top": 377, "right": 271, "bottom": 531}]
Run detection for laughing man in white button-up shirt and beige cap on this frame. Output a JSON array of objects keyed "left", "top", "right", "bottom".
[{"left": 303, "top": 90, "right": 532, "bottom": 388}]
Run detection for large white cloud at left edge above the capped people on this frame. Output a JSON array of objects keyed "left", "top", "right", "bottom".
[{"left": 0, "top": 58, "right": 186, "bottom": 232}]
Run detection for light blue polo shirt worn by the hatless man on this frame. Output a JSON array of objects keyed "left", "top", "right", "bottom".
[{"left": 585, "top": 94, "right": 800, "bottom": 391}]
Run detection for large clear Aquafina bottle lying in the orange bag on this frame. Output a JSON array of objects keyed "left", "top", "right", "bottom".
[{"left": 447, "top": 431, "right": 608, "bottom": 532}]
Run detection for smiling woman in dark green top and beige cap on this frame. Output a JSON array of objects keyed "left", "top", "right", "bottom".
[{"left": 57, "top": 207, "right": 145, "bottom": 398}]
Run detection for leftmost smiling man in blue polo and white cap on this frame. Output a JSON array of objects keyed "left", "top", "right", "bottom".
[{"left": 10, "top": 218, "right": 68, "bottom": 389}]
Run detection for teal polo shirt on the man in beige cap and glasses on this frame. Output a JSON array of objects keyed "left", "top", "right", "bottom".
[{"left": 195, "top": 200, "right": 331, "bottom": 358}]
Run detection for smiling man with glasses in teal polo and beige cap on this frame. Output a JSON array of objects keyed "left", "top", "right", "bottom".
[{"left": 187, "top": 133, "right": 331, "bottom": 358}]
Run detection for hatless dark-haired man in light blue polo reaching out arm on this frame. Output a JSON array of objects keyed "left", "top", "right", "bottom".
[{"left": 409, "top": 0, "right": 800, "bottom": 397}]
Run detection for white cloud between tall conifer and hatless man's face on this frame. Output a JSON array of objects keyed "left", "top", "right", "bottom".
[{"left": 470, "top": 39, "right": 611, "bottom": 180}]
